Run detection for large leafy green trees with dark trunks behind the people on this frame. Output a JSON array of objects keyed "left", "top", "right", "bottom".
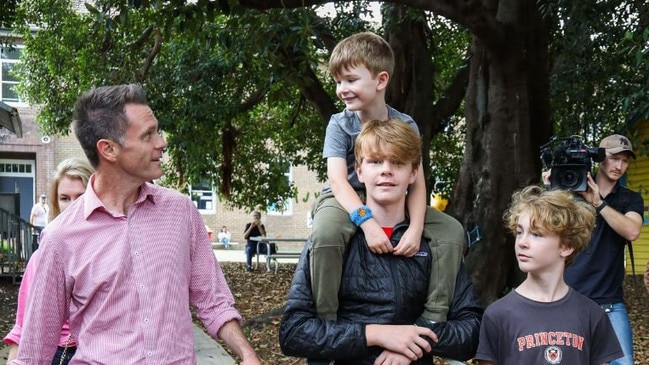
[{"left": 8, "top": 0, "right": 649, "bottom": 302}]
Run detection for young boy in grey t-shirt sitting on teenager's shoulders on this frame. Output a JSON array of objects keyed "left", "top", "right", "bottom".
[{"left": 310, "top": 32, "right": 465, "bottom": 330}]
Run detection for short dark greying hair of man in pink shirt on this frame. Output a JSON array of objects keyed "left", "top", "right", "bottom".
[{"left": 72, "top": 84, "right": 148, "bottom": 168}]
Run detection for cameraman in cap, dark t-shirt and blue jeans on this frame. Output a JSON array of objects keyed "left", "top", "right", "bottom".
[{"left": 543, "top": 134, "right": 644, "bottom": 365}]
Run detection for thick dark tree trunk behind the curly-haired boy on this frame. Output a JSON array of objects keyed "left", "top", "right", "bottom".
[{"left": 455, "top": 0, "right": 551, "bottom": 304}]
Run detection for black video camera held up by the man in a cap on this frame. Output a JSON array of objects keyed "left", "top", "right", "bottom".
[{"left": 541, "top": 136, "right": 606, "bottom": 191}]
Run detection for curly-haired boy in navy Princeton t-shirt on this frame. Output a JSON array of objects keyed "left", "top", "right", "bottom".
[{"left": 475, "top": 186, "right": 624, "bottom": 365}]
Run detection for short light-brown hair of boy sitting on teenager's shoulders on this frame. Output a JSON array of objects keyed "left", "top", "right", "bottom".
[{"left": 329, "top": 32, "right": 394, "bottom": 77}]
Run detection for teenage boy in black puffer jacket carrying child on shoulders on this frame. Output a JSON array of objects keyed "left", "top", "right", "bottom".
[{"left": 279, "top": 119, "right": 483, "bottom": 365}]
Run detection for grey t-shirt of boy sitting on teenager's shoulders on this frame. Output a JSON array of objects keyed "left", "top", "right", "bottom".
[{"left": 322, "top": 105, "right": 419, "bottom": 193}]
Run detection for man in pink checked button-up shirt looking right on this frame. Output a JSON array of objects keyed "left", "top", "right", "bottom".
[{"left": 11, "top": 85, "right": 260, "bottom": 365}]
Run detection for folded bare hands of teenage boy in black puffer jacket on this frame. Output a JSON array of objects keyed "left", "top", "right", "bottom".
[{"left": 365, "top": 324, "right": 437, "bottom": 361}]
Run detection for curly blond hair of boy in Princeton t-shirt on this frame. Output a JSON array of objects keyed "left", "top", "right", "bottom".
[{"left": 503, "top": 185, "right": 595, "bottom": 267}]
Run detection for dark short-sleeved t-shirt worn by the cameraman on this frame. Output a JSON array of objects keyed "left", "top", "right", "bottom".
[{"left": 565, "top": 182, "right": 644, "bottom": 304}]
